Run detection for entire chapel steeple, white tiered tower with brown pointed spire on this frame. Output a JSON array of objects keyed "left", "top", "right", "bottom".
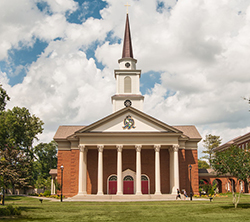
[{"left": 112, "top": 14, "right": 144, "bottom": 112}]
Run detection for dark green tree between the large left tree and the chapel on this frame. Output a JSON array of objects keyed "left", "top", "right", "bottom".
[{"left": 34, "top": 141, "right": 57, "bottom": 189}]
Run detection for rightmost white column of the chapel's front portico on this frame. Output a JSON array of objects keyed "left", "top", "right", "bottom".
[{"left": 170, "top": 144, "right": 180, "bottom": 194}]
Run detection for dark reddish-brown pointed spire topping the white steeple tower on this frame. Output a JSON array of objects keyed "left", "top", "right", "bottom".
[{"left": 122, "top": 13, "right": 134, "bottom": 58}]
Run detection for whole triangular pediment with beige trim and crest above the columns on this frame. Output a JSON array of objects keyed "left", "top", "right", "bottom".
[{"left": 78, "top": 107, "right": 181, "bottom": 133}]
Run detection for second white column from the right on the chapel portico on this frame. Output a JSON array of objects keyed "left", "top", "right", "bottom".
[{"left": 154, "top": 144, "right": 161, "bottom": 195}]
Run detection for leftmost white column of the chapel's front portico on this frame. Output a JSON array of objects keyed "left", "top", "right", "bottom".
[{"left": 78, "top": 145, "right": 87, "bottom": 194}]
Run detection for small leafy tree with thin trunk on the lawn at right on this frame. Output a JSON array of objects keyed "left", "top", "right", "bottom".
[{"left": 211, "top": 145, "right": 250, "bottom": 208}]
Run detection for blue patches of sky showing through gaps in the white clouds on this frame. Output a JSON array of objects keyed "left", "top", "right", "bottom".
[{"left": 0, "top": 0, "right": 160, "bottom": 94}]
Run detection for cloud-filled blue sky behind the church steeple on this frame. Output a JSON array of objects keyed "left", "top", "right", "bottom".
[{"left": 0, "top": 0, "right": 250, "bottom": 157}]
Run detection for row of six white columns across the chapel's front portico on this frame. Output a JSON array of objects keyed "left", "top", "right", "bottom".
[{"left": 78, "top": 144, "right": 179, "bottom": 195}]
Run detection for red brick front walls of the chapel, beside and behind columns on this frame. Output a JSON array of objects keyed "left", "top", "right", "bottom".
[{"left": 57, "top": 147, "right": 199, "bottom": 197}]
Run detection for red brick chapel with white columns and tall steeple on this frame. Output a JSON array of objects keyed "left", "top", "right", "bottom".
[{"left": 54, "top": 14, "right": 201, "bottom": 197}]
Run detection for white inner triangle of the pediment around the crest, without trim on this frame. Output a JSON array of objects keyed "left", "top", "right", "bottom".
[{"left": 90, "top": 111, "right": 167, "bottom": 132}]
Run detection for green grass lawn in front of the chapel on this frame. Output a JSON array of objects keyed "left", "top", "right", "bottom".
[{"left": 0, "top": 195, "right": 250, "bottom": 222}]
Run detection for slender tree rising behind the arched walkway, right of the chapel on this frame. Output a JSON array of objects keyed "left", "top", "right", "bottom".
[{"left": 202, "top": 134, "right": 221, "bottom": 166}]
